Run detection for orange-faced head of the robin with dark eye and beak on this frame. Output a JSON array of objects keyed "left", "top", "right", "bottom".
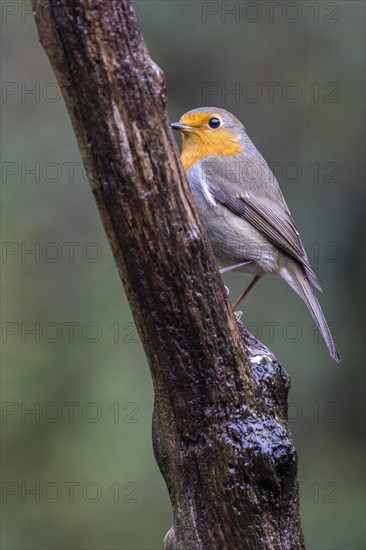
[{"left": 171, "top": 107, "right": 246, "bottom": 170}]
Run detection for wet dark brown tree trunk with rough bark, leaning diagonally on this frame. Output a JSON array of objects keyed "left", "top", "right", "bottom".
[{"left": 33, "top": 0, "right": 303, "bottom": 550}]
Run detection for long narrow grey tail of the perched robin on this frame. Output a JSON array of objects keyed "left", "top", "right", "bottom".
[{"left": 281, "top": 265, "right": 340, "bottom": 363}]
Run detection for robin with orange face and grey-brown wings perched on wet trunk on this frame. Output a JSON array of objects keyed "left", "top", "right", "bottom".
[{"left": 171, "top": 107, "right": 340, "bottom": 362}]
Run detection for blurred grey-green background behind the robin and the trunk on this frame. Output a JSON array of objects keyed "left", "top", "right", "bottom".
[{"left": 1, "top": 0, "right": 365, "bottom": 550}]
